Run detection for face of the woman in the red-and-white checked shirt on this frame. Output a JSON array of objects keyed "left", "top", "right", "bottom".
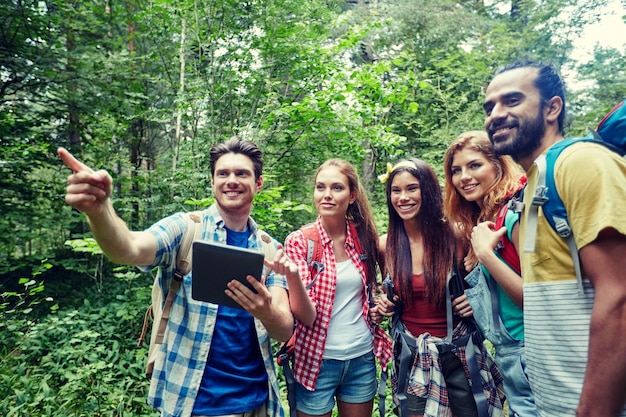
[{"left": 313, "top": 165, "right": 356, "bottom": 219}]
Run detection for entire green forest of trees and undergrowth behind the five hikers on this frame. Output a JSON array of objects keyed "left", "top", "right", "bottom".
[{"left": 0, "top": 0, "right": 626, "bottom": 416}]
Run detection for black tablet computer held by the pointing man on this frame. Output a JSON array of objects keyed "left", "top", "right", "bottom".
[{"left": 191, "top": 241, "right": 264, "bottom": 308}]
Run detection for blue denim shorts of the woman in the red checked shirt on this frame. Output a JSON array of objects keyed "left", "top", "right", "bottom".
[{"left": 296, "top": 352, "right": 378, "bottom": 416}]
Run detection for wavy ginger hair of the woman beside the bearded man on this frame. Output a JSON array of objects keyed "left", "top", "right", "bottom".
[{"left": 444, "top": 130, "right": 526, "bottom": 263}]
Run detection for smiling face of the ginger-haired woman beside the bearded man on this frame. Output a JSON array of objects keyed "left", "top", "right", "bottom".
[{"left": 450, "top": 148, "right": 498, "bottom": 206}]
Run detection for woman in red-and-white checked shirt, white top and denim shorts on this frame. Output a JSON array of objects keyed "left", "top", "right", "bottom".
[{"left": 285, "top": 159, "right": 392, "bottom": 417}]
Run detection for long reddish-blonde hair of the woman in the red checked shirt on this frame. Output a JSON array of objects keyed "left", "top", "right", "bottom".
[{"left": 315, "top": 158, "right": 379, "bottom": 284}]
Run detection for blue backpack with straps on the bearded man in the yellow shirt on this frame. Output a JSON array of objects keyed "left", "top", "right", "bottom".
[{"left": 524, "top": 100, "right": 626, "bottom": 293}]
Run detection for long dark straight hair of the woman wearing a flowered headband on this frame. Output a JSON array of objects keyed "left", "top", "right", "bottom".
[{"left": 385, "top": 158, "right": 454, "bottom": 304}]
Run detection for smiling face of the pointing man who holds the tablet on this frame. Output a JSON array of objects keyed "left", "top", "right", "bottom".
[{"left": 211, "top": 153, "right": 263, "bottom": 217}]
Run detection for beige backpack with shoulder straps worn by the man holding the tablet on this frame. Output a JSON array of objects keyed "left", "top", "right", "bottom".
[{"left": 137, "top": 211, "right": 276, "bottom": 378}]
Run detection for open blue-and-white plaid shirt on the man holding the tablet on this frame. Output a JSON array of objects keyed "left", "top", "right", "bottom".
[{"left": 141, "top": 204, "right": 287, "bottom": 417}]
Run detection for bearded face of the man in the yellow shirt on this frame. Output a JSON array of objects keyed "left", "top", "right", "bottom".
[{"left": 483, "top": 67, "right": 546, "bottom": 161}]
